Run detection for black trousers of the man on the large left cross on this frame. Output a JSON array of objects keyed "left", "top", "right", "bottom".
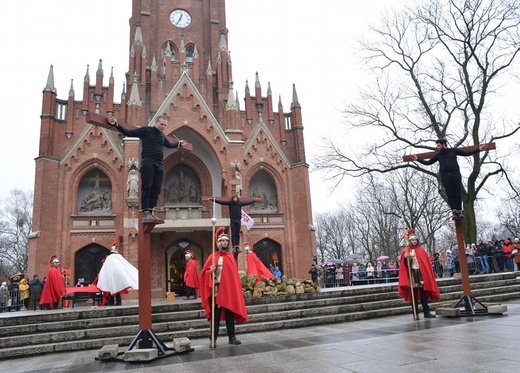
[{"left": 140, "top": 159, "right": 164, "bottom": 211}]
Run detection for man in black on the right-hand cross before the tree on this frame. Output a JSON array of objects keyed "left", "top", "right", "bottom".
[{"left": 412, "top": 139, "right": 487, "bottom": 218}]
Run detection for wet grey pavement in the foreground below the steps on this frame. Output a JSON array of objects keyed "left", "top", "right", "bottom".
[{"left": 0, "top": 302, "right": 520, "bottom": 373}]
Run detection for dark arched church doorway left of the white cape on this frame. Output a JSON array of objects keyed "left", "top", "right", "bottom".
[{"left": 74, "top": 244, "right": 110, "bottom": 284}]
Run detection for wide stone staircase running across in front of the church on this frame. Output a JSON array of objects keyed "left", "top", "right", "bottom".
[{"left": 0, "top": 272, "right": 520, "bottom": 360}]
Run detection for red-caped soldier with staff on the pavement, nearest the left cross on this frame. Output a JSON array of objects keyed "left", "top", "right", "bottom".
[{"left": 200, "top": 228, "right": 248, "bottom": 347}]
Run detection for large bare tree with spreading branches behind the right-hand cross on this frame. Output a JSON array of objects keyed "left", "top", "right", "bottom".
[{"left": 314, "top": 0, "right": 520, "bottom": 242}]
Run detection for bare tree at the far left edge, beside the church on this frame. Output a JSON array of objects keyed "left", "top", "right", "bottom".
[{"left": 0, "top": 189, "right": 33, "bottom": 274}]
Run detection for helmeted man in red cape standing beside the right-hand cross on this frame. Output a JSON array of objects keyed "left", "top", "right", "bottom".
[{"left": 398, "top": 232, "right": 441, "bottom": 320}]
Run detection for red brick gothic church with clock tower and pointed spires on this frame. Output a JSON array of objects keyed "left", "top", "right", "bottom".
[{"left": 29, "top": 0, "right": 316, "bottom": 298}]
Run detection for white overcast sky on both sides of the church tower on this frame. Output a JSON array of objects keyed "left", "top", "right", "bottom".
[{"left": 0, "top": 0, "right": 412, "bottom": 213}]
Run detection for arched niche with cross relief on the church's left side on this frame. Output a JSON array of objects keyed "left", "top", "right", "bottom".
[{"left": 78, "top": 168, "right": 112, "bottom": 215}]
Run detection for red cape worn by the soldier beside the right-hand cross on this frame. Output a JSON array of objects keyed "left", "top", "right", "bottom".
[{"left": 398, "top": 246, "right": 441, "bottom": 301}]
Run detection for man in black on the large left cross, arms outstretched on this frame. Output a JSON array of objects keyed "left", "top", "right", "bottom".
[{"left": 107, "top": 114, "right": 186, "bottom": 220}]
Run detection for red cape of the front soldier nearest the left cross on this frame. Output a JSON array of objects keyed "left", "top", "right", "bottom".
[{"left": 200, "top": 251, "right": 248, "bottom": 322}]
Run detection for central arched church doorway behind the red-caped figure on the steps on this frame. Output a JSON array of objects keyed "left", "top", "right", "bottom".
[{"left": 166, "top": 239, "right": 202, "bottom": 295}]
